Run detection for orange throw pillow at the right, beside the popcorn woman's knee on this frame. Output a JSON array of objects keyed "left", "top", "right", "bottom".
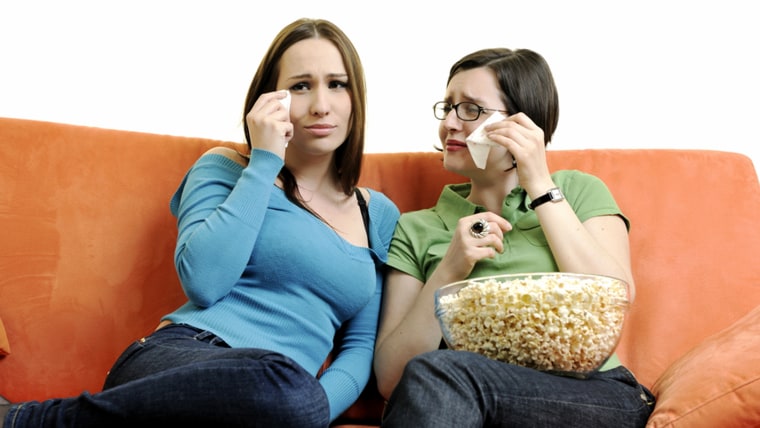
[{"left": 647, "top": 307, "right": 760, "bottom": 428}]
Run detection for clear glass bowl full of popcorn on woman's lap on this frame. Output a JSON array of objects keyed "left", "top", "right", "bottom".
[{"left": 435, "top": 272, "right": 634, "bottom": 378}]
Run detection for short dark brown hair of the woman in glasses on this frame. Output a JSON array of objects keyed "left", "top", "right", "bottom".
[{"left": 446, "top": 48, "right": 559, "bottom": 144}]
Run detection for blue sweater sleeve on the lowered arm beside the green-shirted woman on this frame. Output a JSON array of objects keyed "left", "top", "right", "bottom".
[{"left": 319, "top": 192, "right": 399, "bottom": 421}]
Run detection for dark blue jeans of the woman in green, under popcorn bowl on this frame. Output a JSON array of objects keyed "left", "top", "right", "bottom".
[{"left": 382, "top": 350, "right": 654, "bottom": 428}]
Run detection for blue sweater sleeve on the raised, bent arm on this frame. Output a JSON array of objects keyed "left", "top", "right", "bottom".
[{"left": 170, "top": 150, "right": 283, "bottom": 307}]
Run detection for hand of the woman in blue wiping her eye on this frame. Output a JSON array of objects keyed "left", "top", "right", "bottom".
[{"left": 245, "top": 91, "right": 293, "bottom": 159}]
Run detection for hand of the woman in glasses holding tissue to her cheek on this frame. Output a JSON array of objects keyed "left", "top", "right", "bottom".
[{"left": 486, "top": 113, "right": 553, "bottom": 194}]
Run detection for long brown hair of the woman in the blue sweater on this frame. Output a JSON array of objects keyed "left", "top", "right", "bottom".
[{"left": 243, "top": 18, "right": 367, "bottom": 211}]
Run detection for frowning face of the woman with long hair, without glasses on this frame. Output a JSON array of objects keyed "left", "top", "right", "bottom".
[{"left": 277, "top": 38, "right": 351, "bottom": 154}]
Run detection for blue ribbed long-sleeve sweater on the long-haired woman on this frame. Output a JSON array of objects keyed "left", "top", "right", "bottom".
[{"left": 164, "top": 150, "right": 399, "bottom": 419}]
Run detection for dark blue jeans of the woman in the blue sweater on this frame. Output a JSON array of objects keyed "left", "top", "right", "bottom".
[{"left": 4, "top": 324, "right": 330, "bottom": 428}]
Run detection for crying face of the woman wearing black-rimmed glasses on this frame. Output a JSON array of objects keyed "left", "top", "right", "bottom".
[{"left": 438, "top": 67, "right": 512, "bottom": 176}]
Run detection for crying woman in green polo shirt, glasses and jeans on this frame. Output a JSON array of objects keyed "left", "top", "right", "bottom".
[{"left": 374, "top": 48, "right": 654, "bottom": 428}]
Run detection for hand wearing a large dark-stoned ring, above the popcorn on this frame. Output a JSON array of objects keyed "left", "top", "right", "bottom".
[{"left": 437, "top": 212, "right": 512, "bottom": 282}]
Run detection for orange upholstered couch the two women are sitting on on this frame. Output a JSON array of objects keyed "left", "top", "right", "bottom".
[{"left": 0, "top": 118, "right": 760, "bottom": 427}]
